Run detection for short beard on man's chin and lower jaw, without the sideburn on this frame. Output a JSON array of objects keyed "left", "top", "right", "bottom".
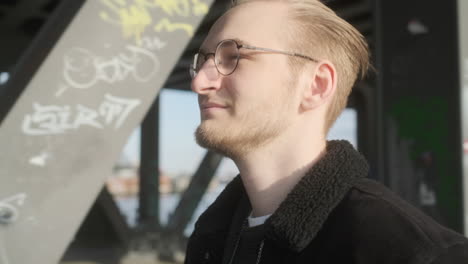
[{"left": 195, "top": 105, "right": 288, "bottom": 160}]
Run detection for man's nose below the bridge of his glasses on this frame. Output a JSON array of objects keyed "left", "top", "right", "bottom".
[{"left": 191, "top": 58, "right": 221, "bottom": 94}]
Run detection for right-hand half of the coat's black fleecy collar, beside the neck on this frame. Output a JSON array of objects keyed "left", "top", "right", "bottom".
[{"left": 265, "top": 140, "right": 369, "bottom": 252}]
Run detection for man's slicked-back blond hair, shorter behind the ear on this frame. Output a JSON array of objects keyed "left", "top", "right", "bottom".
[{"left": 232, "top": 0, "right": 370, "bottom": 133}]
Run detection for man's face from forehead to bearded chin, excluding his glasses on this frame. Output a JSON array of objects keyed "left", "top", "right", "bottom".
[{"left": 192, "top": 1, "right": 298, "bottom": 158}]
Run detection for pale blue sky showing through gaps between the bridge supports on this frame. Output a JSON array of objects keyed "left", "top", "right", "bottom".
[{"left": 119, "top": 89, "right": 357, "bottom": 176}]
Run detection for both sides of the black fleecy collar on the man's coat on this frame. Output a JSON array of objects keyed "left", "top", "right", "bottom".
[{"left": 195, "top": 140, "right": 368, "bottom": 255}]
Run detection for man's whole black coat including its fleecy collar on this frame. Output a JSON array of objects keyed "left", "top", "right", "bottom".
[{"left": 185, "top": 141, "right": 468, "bottom": 264}]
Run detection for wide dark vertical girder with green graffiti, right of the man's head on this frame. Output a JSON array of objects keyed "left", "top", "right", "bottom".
[{"left": 374, "top": 0, "right": 463, "bottom": 232}]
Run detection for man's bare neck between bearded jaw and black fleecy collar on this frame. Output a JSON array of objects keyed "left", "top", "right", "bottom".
[{"left": 234, "top": 127, "right": 326, "bottom": 217}]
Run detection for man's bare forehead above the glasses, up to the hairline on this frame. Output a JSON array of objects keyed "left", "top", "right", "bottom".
[{"left": 201, "top": 1, "right": 288, "bottom": 50}]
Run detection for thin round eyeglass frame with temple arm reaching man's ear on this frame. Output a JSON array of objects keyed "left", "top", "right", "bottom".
[{"left": 190, "top": 39, "right": 319, "bottom": 78}]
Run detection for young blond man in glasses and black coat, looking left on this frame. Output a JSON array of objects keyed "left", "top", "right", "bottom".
[{"left": 186, "top": 0, "right": 468, "bottom": 264}]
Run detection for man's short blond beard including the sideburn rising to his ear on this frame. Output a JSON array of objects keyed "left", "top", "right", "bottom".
[{"left": 195, "top": 69, "right": 297, "bottom": 160}]
